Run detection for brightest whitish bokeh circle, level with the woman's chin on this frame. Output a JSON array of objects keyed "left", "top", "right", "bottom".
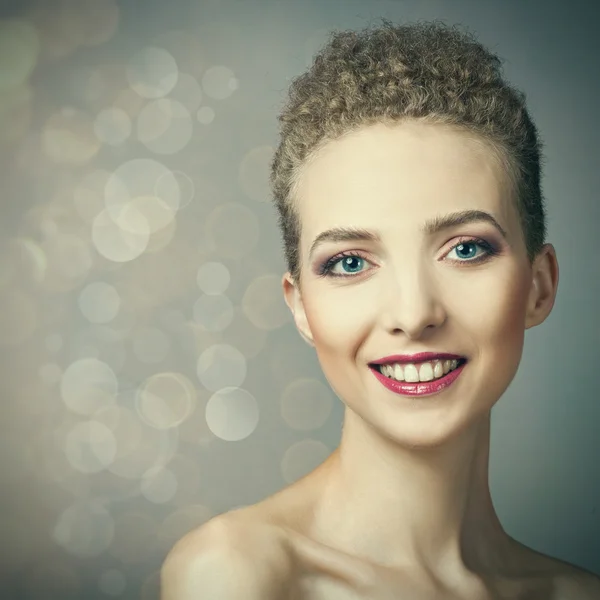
[{"left": 206, "top": 387, "right": 259, "bottom": 442}]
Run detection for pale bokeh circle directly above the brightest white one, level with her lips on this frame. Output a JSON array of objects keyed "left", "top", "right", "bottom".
[{"left": 196, "top": 344, "right": 246, "bottom": 392}]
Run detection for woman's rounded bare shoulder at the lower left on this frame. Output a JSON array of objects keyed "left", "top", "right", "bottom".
[{"left": 160, "top": 514, "right": 286, "bottom": 600}]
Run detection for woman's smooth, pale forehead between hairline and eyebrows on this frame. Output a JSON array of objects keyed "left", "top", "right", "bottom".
[{"left": 297, "top": 122, "right": 514, "bottom": 247}]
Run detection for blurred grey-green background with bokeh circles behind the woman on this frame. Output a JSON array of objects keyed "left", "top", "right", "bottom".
[{"left": 0, "top": 0, "right": 600, "bottom": 600}]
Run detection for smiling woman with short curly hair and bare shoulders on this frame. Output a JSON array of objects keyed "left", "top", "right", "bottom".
[{"left": 162, "top": 20, "right": 600, "bottom": 600}]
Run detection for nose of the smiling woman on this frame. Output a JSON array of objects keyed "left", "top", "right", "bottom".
[{"left": 380, "top": 266, "right": 447, "bottom": 339}]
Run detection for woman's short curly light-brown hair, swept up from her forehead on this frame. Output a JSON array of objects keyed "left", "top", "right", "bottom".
[{"left": 270, "top": 19, "right": 546, "bottom": 285}]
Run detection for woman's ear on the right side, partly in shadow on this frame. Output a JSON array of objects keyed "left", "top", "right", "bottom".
[{"left": 525, "top": 244, "right": 558, "bottom": 329}]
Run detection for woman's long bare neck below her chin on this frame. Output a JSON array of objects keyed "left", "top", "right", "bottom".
[{"left": 312, "top": 409, "right": 514, "bottom": 576}]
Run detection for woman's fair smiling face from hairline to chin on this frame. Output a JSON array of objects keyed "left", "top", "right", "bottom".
[{"left": 284, "top": 122, "right": 551, "bottom": 446}]
